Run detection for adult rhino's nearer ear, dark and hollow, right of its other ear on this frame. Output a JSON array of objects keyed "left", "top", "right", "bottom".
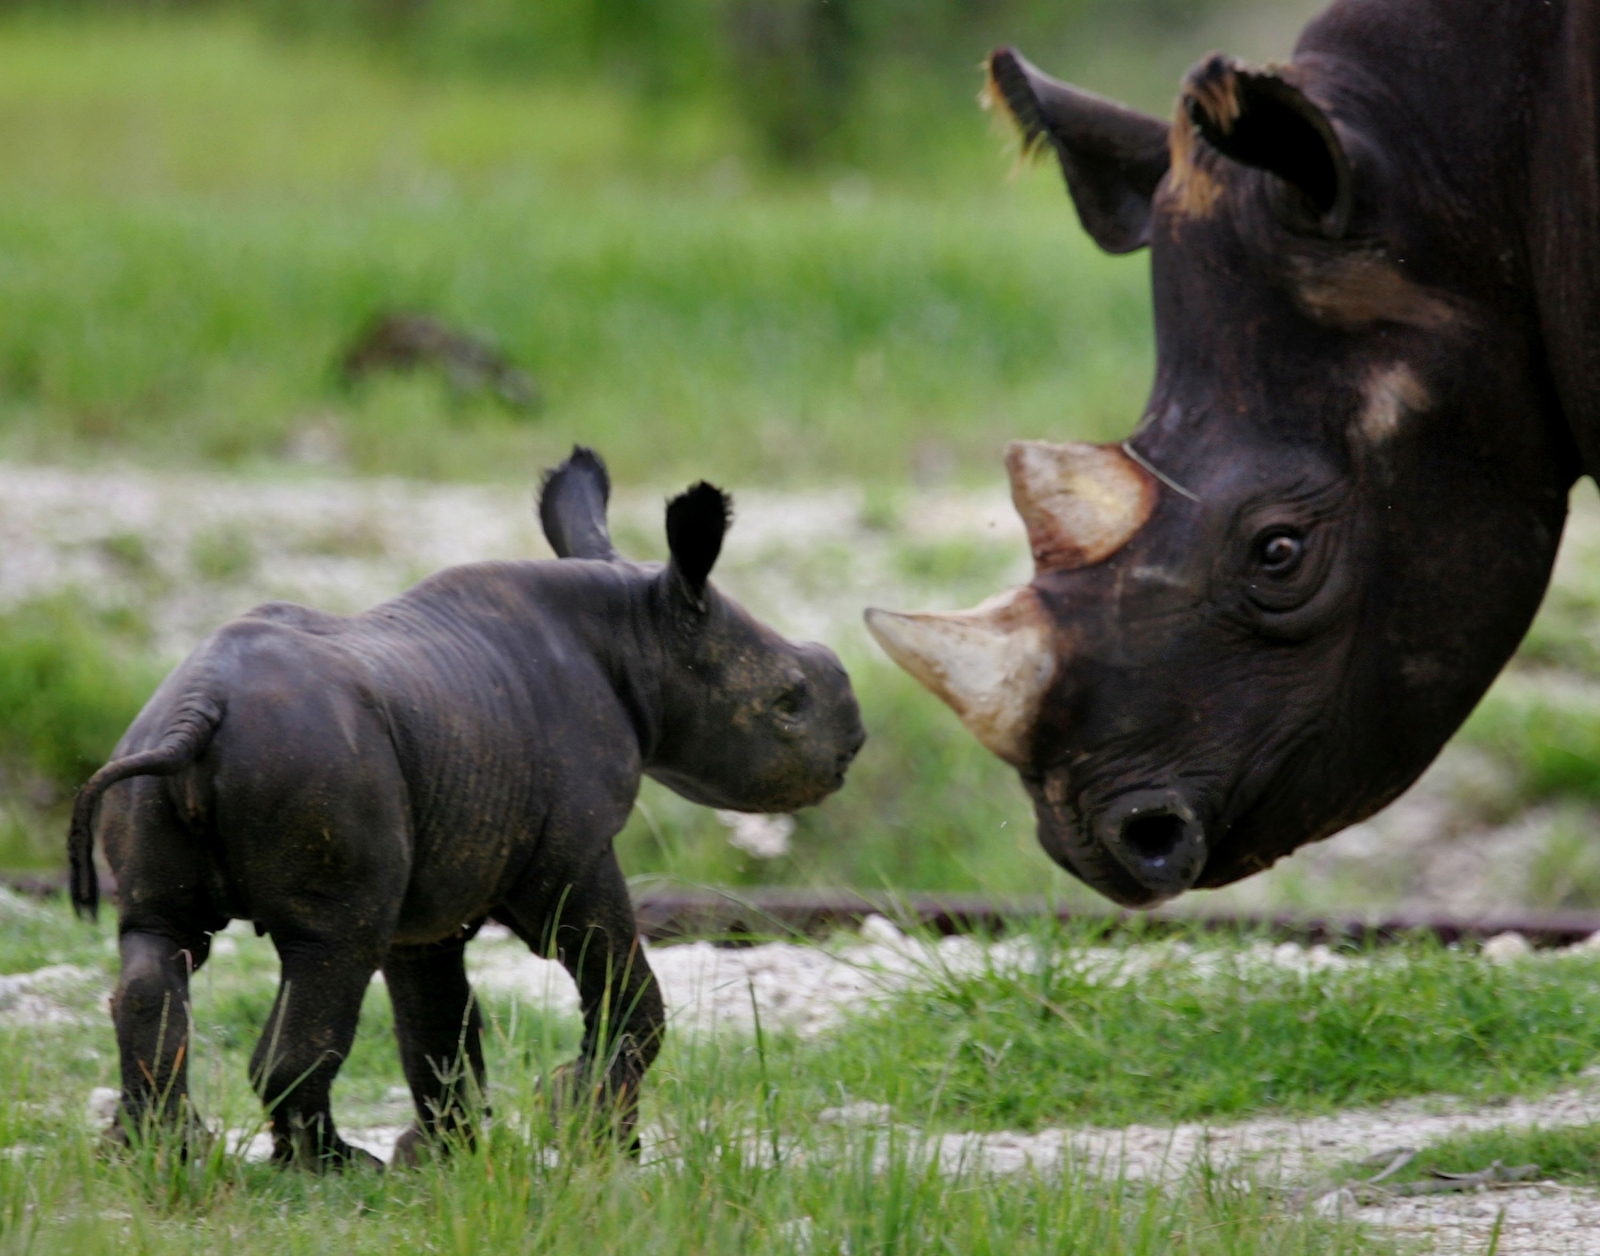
[{"left": 1182, "top": 53, "right": 1352, "bottom": 238}]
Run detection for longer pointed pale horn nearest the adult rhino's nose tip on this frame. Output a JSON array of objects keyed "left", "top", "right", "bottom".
[{"left": 866, "top": 587, "right": 1056, "bottom": 766}]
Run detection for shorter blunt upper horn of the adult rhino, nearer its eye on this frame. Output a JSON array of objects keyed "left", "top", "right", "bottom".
[{"left": 1005, "top": 440, "right": 1157, "bottom": 571}]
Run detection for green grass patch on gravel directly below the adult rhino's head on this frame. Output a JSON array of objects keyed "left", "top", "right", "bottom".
[{"left": 812, "top": 930, "right": 1600, "bottom": 1128}]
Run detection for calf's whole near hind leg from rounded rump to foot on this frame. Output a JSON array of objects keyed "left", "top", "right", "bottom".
[{"left": 220, "top": 684, "right": 410, "bottom": 1170}]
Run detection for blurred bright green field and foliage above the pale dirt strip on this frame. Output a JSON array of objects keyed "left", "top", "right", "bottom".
[{"left": 0, "top": 0, "right": 1304, "bottom": 485}]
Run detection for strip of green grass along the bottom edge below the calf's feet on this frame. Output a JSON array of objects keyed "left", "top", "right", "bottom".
[{"left": 0, "top": 1113, "right": 1394, "bottom": 1256}]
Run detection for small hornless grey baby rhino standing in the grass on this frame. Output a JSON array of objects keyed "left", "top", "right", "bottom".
[{"left": 70, "top": 448, "right": 866, "bottom": 1166}]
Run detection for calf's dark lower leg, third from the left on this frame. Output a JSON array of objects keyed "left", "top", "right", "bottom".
[{"left": 384, "top": 938, "right": 483, "bottom": 1165}]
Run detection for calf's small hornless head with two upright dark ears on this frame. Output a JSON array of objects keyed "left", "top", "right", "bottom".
[{"left": 539, "top": 448, "right": 866, "bottom": 813}]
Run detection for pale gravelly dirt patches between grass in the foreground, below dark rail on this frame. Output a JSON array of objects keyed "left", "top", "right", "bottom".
[{"left": 37, "top": 904, "right": 1600, "bottom": 1256}]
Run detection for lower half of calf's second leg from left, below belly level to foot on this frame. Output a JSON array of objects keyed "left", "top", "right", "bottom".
[{"left": 250, "top": 928, "right": 382, "bottom": 1170}]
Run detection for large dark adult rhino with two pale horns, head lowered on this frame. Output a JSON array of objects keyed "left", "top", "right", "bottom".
[{"left": 867, "top": 0, "right": 1600, "bottom": 906}]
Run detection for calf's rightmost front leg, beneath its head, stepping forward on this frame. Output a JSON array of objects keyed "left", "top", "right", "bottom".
[{"left": 508, "top": 846, "right": 666, "bottom": 1152}]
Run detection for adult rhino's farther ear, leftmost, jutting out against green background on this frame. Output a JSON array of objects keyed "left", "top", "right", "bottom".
[{"left": 984, "top": 48, "right": 1170, "bottom": 253}]
